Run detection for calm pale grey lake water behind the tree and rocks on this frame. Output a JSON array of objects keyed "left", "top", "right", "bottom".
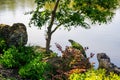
[{"left": 0, "top": 0, "right": 120, "bottom": 66}]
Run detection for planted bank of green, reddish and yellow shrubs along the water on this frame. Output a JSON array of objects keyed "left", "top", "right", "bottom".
[{"left": 0, "top": 46, "right": 120, "bottom": 80}]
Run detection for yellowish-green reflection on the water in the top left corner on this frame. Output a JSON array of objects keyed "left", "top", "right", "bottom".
[{"left": 0, "top": 0, "right": 35, "bottom": 12}]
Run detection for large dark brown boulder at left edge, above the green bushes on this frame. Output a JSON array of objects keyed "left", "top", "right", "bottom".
[{"left": 0, "top": 23, "right": 28, "bottom": 47}]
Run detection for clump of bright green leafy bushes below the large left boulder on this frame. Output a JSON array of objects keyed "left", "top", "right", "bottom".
[{"left": 0, "top": 46, "right": 57, "bottom": 80}]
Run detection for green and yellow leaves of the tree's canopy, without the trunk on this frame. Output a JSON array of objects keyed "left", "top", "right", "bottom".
[{"left": 32, "top": 0, "right": 120, "bottom": 28}]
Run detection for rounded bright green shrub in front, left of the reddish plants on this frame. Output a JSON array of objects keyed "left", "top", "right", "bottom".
[{"left": 19, "top": 56, "right": 52, "bottom": 80}]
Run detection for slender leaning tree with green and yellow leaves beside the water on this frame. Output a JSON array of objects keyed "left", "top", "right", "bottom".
[{"left": 30, "top": 0, "right": 119, "bottom": 52}]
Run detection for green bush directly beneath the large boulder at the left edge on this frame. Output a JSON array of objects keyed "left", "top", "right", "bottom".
[{"left": 0, "top": 46, "right": 35, "bottom": 68}]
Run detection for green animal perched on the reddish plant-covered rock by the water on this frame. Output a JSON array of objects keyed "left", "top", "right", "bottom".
[{"left": 68, "top": 39, "right": 87, "bottom": 58}]
